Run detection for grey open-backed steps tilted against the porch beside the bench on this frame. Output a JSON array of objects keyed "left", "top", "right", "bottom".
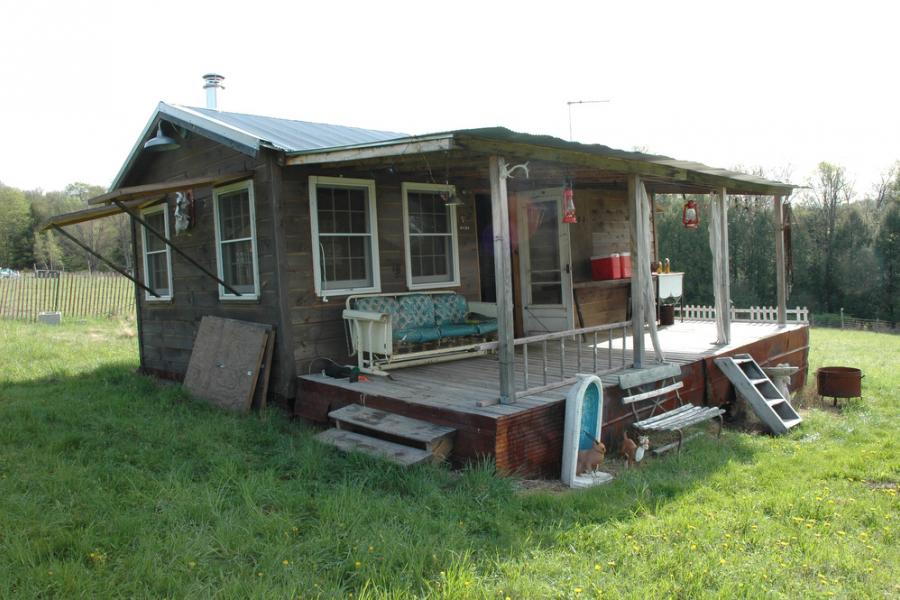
[{"left": 715, "top": 354, "right": 803, "bottom": 435}]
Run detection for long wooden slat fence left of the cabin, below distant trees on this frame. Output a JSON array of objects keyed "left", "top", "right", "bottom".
[{"left": 0, "top": 271, "right": 135, "bottom": 321}]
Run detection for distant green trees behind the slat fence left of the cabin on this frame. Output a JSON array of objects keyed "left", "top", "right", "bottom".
[{"left": 0, "top": 183, "right": 133, "bottom": 272}]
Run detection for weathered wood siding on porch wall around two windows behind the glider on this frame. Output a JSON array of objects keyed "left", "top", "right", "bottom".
[{"left": 282, "top": 167, "right": 480, "bottom": 373}]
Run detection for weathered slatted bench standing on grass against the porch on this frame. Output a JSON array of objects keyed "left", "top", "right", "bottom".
[{"left": 619, "top": 364, "right": 725, "bottom": 454}]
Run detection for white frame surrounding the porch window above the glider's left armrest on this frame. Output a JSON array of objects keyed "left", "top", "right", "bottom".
[{"left": 309, "top": 175, "right": 381, "bottom": 298}]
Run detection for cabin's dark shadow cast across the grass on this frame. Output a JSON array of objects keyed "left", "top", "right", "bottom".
[{"left": 0, "top": 363, "right": 754, "bottom": 593}]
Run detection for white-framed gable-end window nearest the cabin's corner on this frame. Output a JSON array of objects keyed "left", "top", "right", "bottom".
[{"left": 213, "top": 181, "right": 259, "bottom": 300}]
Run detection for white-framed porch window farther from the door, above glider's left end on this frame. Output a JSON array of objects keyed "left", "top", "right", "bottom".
[{"left": 309, "top": 176, "right": 381, "bottom": 296}]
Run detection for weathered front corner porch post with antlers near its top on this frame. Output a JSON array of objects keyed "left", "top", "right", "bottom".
[{"left": 489, "top": 156, "right": 516, "bottom": 404}]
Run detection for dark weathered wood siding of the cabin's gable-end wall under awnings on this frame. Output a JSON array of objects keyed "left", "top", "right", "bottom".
[{"left": 123, "top": 135, "right": 294, "bottom": 398}]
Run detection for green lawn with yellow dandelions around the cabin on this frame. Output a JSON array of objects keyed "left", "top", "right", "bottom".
[{"left": 0, "top": 322, "right": 900, "bottom": 599}]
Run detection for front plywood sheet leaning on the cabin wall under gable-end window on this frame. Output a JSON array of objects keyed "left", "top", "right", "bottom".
[{"left": 184, "top": 317, "right": 269, "bottom": 412}]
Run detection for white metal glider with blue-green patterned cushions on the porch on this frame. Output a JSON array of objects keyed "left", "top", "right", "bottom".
[{"left": 343, "top": 291, "right": 497, "bottom": 375}]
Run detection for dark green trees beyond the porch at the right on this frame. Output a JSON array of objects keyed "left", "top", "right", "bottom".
[{"left": 656, "top": 161, "right": 900, "bottom": 323}]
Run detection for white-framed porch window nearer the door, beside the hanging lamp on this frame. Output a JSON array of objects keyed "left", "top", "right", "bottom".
[{"left": 402, "top": 183, "right": 459, "bottom": 290}]
